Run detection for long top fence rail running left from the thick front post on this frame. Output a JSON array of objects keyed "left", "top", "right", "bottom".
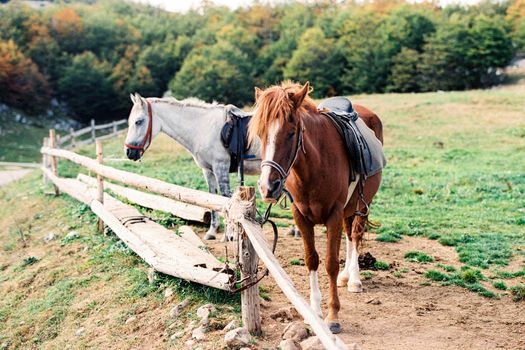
[{"left": 40, "top": 147, "right": 229, "bottom": 212}]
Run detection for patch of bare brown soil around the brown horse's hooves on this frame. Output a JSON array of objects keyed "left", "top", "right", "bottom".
[{"left": 210, "top": 230, "right": 525, "bottom": 350}]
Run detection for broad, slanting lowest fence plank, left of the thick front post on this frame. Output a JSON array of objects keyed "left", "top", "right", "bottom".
[{"left": 42, "top": 168, "right": 230, "bottom": 290}]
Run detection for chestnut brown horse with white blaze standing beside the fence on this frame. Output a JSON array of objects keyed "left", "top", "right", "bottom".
[{"left": 249, "top": 82, "right": 383, "bottom": 333}]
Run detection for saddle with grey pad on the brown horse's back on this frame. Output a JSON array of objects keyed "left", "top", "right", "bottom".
[{"left": 317, "top": 96, "right": 386, "bottom": 181}]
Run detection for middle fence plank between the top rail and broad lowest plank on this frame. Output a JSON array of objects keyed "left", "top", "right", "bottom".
[{"left": 77, "top": 174, "right": 211, "bottom": 224}]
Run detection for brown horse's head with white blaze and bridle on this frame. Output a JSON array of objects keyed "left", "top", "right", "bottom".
[{"left": 249, "top": 81, "right": 316, "bottom": 203}]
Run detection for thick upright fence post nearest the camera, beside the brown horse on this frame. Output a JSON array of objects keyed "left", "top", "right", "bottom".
[{"left": 236, "top": 186, "right": 262, "bottom": 336}]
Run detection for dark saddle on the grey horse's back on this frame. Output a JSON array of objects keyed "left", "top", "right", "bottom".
[{"left": 221, "top": 105, "right": 253, "bottom": 173}]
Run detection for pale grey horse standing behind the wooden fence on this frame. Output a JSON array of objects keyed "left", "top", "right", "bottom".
[{"left": 124, "top": 93, "right": 261, "bottom": 240}]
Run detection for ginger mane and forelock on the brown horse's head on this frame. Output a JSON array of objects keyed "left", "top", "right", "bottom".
[{"left": 248, "top": 80, "right": 317, "bottom": 144}]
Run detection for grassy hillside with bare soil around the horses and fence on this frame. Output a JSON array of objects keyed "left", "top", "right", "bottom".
[{"left": 0, "top": 72, "right": 525, "bottom": 349}]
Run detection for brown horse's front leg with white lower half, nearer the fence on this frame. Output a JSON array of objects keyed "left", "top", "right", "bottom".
[{"left": 292, "top": 206, "right": 323, "bottom": 317}]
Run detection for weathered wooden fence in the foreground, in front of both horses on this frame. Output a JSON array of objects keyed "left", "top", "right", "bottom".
[{"left": 41, "top": 131, "right": 347, "bottom": 349}]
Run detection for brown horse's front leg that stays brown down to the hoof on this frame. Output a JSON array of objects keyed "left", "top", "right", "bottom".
[{"left": 325, "top": 210, "right": 343, "bottom": 334}]
